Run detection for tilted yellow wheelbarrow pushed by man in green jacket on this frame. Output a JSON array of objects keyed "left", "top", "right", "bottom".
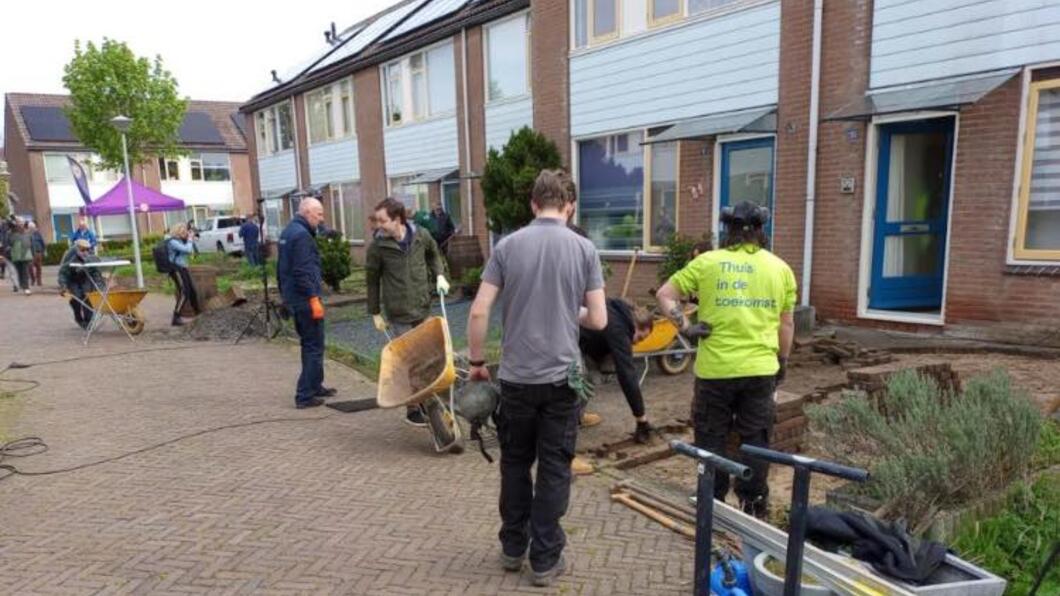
[{"left": 375, "top": 296, "right": 463, "bottom": 453}]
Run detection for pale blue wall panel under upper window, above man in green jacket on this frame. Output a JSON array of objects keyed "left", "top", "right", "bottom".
[{"left": 383, "top": 117, "right": 460, "bottom": 176}]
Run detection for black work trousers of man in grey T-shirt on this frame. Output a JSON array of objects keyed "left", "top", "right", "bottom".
[{"left": 497, "top": 381, "right": 579, "bottom": 572}]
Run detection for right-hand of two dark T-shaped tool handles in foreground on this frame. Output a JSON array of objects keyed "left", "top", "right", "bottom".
[{"left": 740, "top": 444, "right": 868, "bottom": 596}]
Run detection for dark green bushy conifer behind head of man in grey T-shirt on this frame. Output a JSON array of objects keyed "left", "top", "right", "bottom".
[{"left": 482, "top": 126, "right": 563, "bottom": 233}]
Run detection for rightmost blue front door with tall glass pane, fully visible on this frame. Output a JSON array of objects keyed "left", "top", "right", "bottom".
[{"left": 868, "top": 118, "right": 953, "bottom": 312}]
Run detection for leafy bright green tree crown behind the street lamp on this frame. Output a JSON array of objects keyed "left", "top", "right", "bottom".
[{"left": 63, "top": 38, "right": 188, "bottom": 171}]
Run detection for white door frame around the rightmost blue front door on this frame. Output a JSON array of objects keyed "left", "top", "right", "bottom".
[{"left": 852, "top": 111, "right": 960, "bottom": 327}]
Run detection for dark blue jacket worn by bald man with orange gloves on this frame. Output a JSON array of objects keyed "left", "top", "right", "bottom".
[{"left": 276, "top": 215, "right": 322, "bottom": 309}]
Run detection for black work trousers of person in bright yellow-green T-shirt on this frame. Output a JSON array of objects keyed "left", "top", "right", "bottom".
[{"left": 692, "top": 375, "right": 776, "bottom": 502}]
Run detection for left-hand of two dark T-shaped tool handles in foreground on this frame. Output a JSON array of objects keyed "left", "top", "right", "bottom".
[{"left": 670, "top": 439, "right": 750, "bottom": 596}]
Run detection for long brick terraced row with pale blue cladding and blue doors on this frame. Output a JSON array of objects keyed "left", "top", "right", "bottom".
[{"left": 242, "top": 0, "right": 1060, "bottom": 344}]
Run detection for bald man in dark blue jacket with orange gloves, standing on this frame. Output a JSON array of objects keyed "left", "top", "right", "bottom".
[{"left": 277, "top": 198, "right": 335, "bottom": 409}]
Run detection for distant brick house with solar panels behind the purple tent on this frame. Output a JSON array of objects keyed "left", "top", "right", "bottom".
[{"left": 4, "top": 93, "right": 254, "bottom": 242}]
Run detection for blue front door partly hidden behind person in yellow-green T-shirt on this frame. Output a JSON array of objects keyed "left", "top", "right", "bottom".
[{"left": 716, "top": 137, "right": 773, "bottom": 243}]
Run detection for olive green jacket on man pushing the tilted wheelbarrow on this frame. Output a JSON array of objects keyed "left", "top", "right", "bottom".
[{"left": 365, "top": 222, "right": 445, "bottom": 323}]
